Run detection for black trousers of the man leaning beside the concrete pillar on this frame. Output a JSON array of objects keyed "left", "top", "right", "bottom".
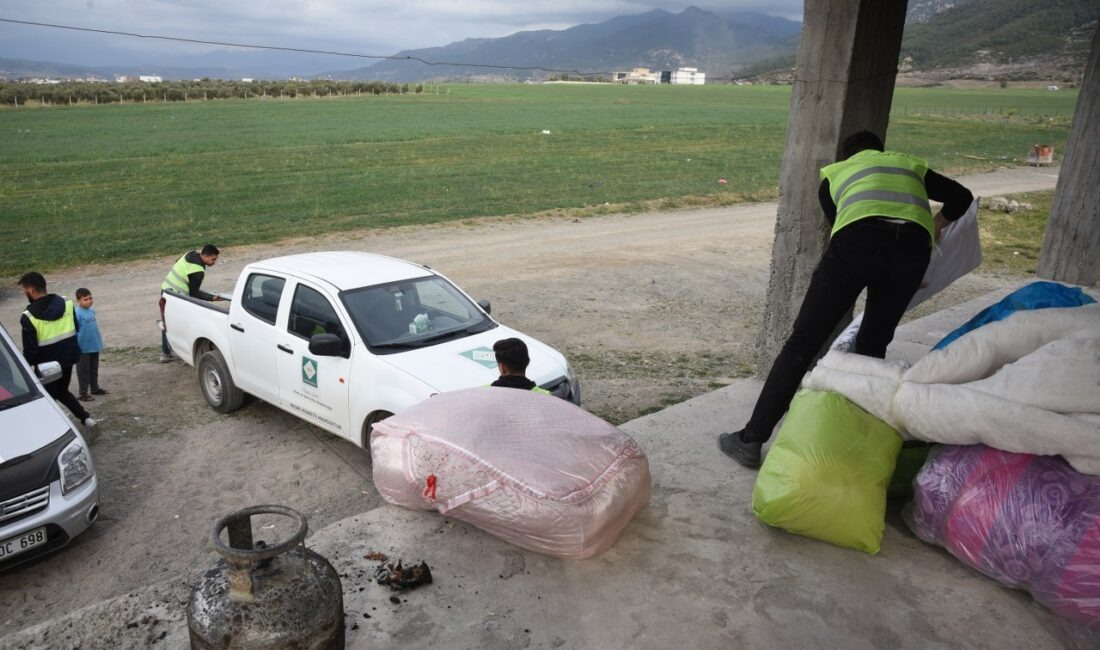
[{"left": 745, "top": 219, "right": 932, "bottom": 442}]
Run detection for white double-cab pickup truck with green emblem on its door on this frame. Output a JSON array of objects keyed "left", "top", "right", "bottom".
[{"left": 164, "top": 252, "right": 580, "bottom": 448}]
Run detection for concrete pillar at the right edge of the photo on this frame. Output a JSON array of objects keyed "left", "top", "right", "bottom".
[{"left": 1038, "top": 26, "right": 1100, "bottom": 286}]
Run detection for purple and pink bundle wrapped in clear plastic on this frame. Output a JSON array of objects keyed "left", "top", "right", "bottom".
[{"left": 904, "top": 444, "right": 1100, "bottom": 646}]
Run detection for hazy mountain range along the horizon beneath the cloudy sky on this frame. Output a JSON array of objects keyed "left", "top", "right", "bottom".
[{"left": 0, "top": 0, "right": 1100, "bottom": 81}]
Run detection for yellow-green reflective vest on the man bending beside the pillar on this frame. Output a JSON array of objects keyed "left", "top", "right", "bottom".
[{"left": 821, "top": 150, "right": 936, "bottom": 243}]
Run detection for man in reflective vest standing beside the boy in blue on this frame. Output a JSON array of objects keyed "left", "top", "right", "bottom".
[{"left": 19, "top": 271, "right": 99, "bottom": 442}]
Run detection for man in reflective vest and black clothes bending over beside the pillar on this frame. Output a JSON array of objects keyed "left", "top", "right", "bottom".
[{"left": 718, "top": 131, "right": 974, "bottom": 467}]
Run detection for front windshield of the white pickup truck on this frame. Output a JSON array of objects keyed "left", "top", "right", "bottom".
[{"left": 340, "top": 275, "right": 496, "bottom": 353}]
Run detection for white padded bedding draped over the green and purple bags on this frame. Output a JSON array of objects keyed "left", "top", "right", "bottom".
[{"left": 804, "top": 305, "right": 1100, "bottom": 474}]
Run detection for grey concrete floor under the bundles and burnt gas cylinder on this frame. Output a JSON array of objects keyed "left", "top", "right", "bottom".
[{"left": 0, "top": 291, "right": 1068, "bottom": 650}]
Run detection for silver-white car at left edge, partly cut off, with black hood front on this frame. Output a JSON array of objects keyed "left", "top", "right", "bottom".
[{"left": 0, "top": 327, "right": 99, "bottom": 571}]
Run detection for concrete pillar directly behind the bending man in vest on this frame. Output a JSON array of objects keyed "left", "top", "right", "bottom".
[{"left": 757, "top": 0, "right": 906, "bottom": 374}]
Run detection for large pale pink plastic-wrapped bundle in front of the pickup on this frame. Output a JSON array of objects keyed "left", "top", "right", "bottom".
[{"left": 371, "top": 387, "right": 650, "bottom": 559}]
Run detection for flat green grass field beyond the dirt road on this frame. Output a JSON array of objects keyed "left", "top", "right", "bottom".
[{"left": 0, "top": 85, "right": 1077, "bottom": 276}]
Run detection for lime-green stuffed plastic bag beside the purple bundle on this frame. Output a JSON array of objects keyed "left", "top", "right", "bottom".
[{"left": 752, "top": 390, "right": 902, "bottom": 554}]
